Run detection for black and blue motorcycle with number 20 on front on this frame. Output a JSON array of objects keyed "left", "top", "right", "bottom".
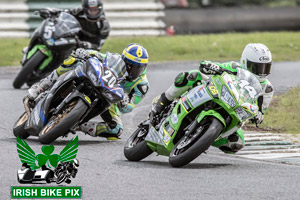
[{"left": 13, "top": 57, "right": 124, "bottom": 144}]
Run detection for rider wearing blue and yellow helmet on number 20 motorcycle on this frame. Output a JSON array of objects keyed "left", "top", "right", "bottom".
[{"left": 24, "top": 44, "right": 149, "bottom": 140}]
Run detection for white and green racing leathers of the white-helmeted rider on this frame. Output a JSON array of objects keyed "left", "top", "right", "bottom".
[{"left": 151, "top": 61, "right": 274, "bottom": 153}]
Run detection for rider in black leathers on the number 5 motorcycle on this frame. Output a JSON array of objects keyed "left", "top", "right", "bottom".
[{"left": 69, "top": 0, "right": 110, "bottom": 51}]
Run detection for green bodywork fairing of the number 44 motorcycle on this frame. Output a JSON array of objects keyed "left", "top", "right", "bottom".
[{"left": 145, "top": 70, "right": 259, "bottom": 156}]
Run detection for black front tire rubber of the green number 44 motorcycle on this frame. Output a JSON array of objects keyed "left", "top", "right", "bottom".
[{"left": 169, "top": 117, "right": 223, "bottom": 167}]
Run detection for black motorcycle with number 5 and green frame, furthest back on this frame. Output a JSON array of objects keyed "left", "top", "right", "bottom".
[{"left": 13, "top": 8, "right": 81, "bottom": 88}]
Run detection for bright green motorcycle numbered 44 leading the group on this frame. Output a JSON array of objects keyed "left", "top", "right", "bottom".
[{"left": 124, "top": 68, "right": 263, "bottom": 167}]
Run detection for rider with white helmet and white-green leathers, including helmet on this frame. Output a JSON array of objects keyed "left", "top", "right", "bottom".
[{"left": 150, "top": 43, "right": 274, "bottom": 153}]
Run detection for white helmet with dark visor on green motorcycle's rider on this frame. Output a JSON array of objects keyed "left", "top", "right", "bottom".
[{"left": 241, "top": 43, "right": 272, "bottom": 82}]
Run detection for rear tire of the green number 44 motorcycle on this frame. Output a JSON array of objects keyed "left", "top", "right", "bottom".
[{"left": 124, "top": 127, "right": 153, "bottom": 161}]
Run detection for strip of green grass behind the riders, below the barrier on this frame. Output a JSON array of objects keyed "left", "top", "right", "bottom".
[{"left": 0, "top": 31, "right": 300, "bottom": 66}]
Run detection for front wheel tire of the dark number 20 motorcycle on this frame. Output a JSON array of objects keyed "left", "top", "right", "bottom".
[{"left": 39, "top": 99, "right": 88, "bottom": 144}]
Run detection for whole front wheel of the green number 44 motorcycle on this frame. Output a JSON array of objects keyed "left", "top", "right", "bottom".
[{"left": 169, "top": 117, "right": 223, "bottom": 167}]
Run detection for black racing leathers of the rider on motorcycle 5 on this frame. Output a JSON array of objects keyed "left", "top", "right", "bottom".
[{"left": 69, "top": 7, "right": 110, "bottom": 50}]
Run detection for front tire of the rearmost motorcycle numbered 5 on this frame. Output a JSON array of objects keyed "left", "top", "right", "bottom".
[{"left": 13, "top": 51, "right": 46, "bottom": 89}]
